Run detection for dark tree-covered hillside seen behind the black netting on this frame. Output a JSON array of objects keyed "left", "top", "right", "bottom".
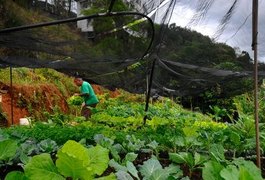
[{"left": 0, "top": 1, "right": 262, "bottom": 118}]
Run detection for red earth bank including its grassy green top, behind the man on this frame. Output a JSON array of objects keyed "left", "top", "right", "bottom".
[{"left": 0, "top": 68, "right": 119, "bottom": 126}]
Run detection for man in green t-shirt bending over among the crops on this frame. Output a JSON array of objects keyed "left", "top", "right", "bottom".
[{"left": 74, "top": 77, "right": 99, "bottom": 119}]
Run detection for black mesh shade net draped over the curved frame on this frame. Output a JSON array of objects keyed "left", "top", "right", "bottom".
[{"left": 0, "top": 0, "right": 262, "bottom": 96}]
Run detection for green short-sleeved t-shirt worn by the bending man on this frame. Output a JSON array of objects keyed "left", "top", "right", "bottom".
[{"left": 80, "top": 81, "right": 99, "bottom": 105}]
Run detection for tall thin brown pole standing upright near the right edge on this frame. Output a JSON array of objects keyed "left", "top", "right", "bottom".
[{"left": 252, "top": 0, "right": 261, "bottom": 168}]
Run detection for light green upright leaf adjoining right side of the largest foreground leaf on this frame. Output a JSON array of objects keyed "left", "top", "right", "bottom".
[{"left": 88, "top": 144, "right": 109, "bottom": 175}]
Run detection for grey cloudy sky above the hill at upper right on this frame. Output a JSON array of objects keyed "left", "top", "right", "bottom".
[{"left": 166, "top": 0, "right": 265, "bottom": 62}]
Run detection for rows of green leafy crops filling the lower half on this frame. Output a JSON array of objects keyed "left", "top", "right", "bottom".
[{"left": 0, "top": 94, "right": 265, "bottom": 180}]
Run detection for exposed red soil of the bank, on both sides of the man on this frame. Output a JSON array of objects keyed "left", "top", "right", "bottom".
[{"left": 0, "top": 82, "right": 120, "bottom": 127}]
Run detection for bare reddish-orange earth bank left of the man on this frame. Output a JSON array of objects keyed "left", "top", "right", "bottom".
[{"left": 0, "top": 84, "right": 69, "bottom": 126}]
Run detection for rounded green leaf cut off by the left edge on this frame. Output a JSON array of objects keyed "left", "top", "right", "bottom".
[{"left": 0, "top": 139, "right": 18, "bottom": 161}]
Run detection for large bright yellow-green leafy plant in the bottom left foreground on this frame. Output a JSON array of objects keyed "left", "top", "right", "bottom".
[{"left": 4, "top": 140, "right": 115, "bottom": 180}]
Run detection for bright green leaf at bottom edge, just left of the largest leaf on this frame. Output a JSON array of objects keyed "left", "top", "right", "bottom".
[{"left": 25, "top": 153, "right": 64, "bottom": 180}]
